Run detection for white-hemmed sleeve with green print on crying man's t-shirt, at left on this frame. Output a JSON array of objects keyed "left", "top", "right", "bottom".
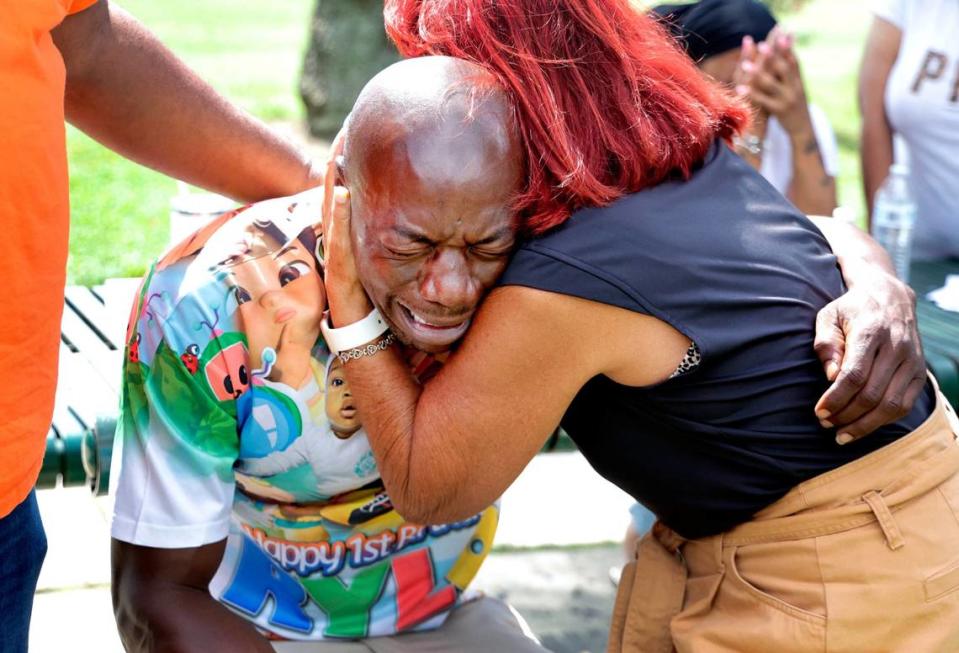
[{"left": 111, "top": 272, "right": 239, "bottom": 548}]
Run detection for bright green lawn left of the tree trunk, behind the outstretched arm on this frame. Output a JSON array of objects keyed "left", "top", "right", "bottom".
[{"left": 67, "top": 0, "right": 313, "bottom": 284}]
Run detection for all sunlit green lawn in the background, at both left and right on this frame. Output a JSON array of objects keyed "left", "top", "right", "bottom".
[{"left": 68, "top": 0, "right": 869, "bottom": 284}]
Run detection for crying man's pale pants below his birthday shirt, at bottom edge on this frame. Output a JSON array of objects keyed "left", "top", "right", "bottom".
[{"left": 273, "top": 596, "right": 548, "bottom": 653}]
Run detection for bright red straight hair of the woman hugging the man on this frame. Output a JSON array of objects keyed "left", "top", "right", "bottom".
[{"left": 384, "top": 0, "right": 749, "bottom": 234}]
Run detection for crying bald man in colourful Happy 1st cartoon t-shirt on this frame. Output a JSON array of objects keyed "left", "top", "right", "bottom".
[{"left": 113, "top": 57, "right": 546, "bottom": 653}]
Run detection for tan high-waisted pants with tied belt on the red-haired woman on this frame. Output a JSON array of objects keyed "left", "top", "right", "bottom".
[{"left": 608, "top": 384, "right": 959, "bottom": 653}]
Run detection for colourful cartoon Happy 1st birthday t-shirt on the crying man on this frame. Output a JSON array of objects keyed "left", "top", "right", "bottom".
[{"left": 112, "top": 191, "right": 498, "bottom": 640}]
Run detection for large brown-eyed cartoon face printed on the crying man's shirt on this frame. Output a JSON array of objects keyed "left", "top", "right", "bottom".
[{"left": 220, "top": 223, "right": 326, "bottom": 389}]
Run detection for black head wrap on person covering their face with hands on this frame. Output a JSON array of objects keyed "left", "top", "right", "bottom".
[{"left": 653, "top": 0, "right": 776, "bottom": 62}]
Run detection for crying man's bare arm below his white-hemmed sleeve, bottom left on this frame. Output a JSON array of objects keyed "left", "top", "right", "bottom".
[{"left": 111, "top": 539, "right": 273, "bottom": 653}]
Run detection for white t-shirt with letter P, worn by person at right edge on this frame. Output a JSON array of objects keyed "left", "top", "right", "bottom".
[{"left": 874, "top": 0, "right": 959, "bottom": 259}]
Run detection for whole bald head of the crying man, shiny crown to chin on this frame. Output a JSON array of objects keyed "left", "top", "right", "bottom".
[{"left": 341, "top": 57, "right": 524, "bottom": 351}]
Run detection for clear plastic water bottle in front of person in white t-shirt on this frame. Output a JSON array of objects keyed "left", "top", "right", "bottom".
[{"left": 872, "top": 163, "right": 916, "bottom": 282}]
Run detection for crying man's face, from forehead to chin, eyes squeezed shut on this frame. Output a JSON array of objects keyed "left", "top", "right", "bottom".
[{"left": 351, "top": 118, "right": 520, "bottom": 353}]
